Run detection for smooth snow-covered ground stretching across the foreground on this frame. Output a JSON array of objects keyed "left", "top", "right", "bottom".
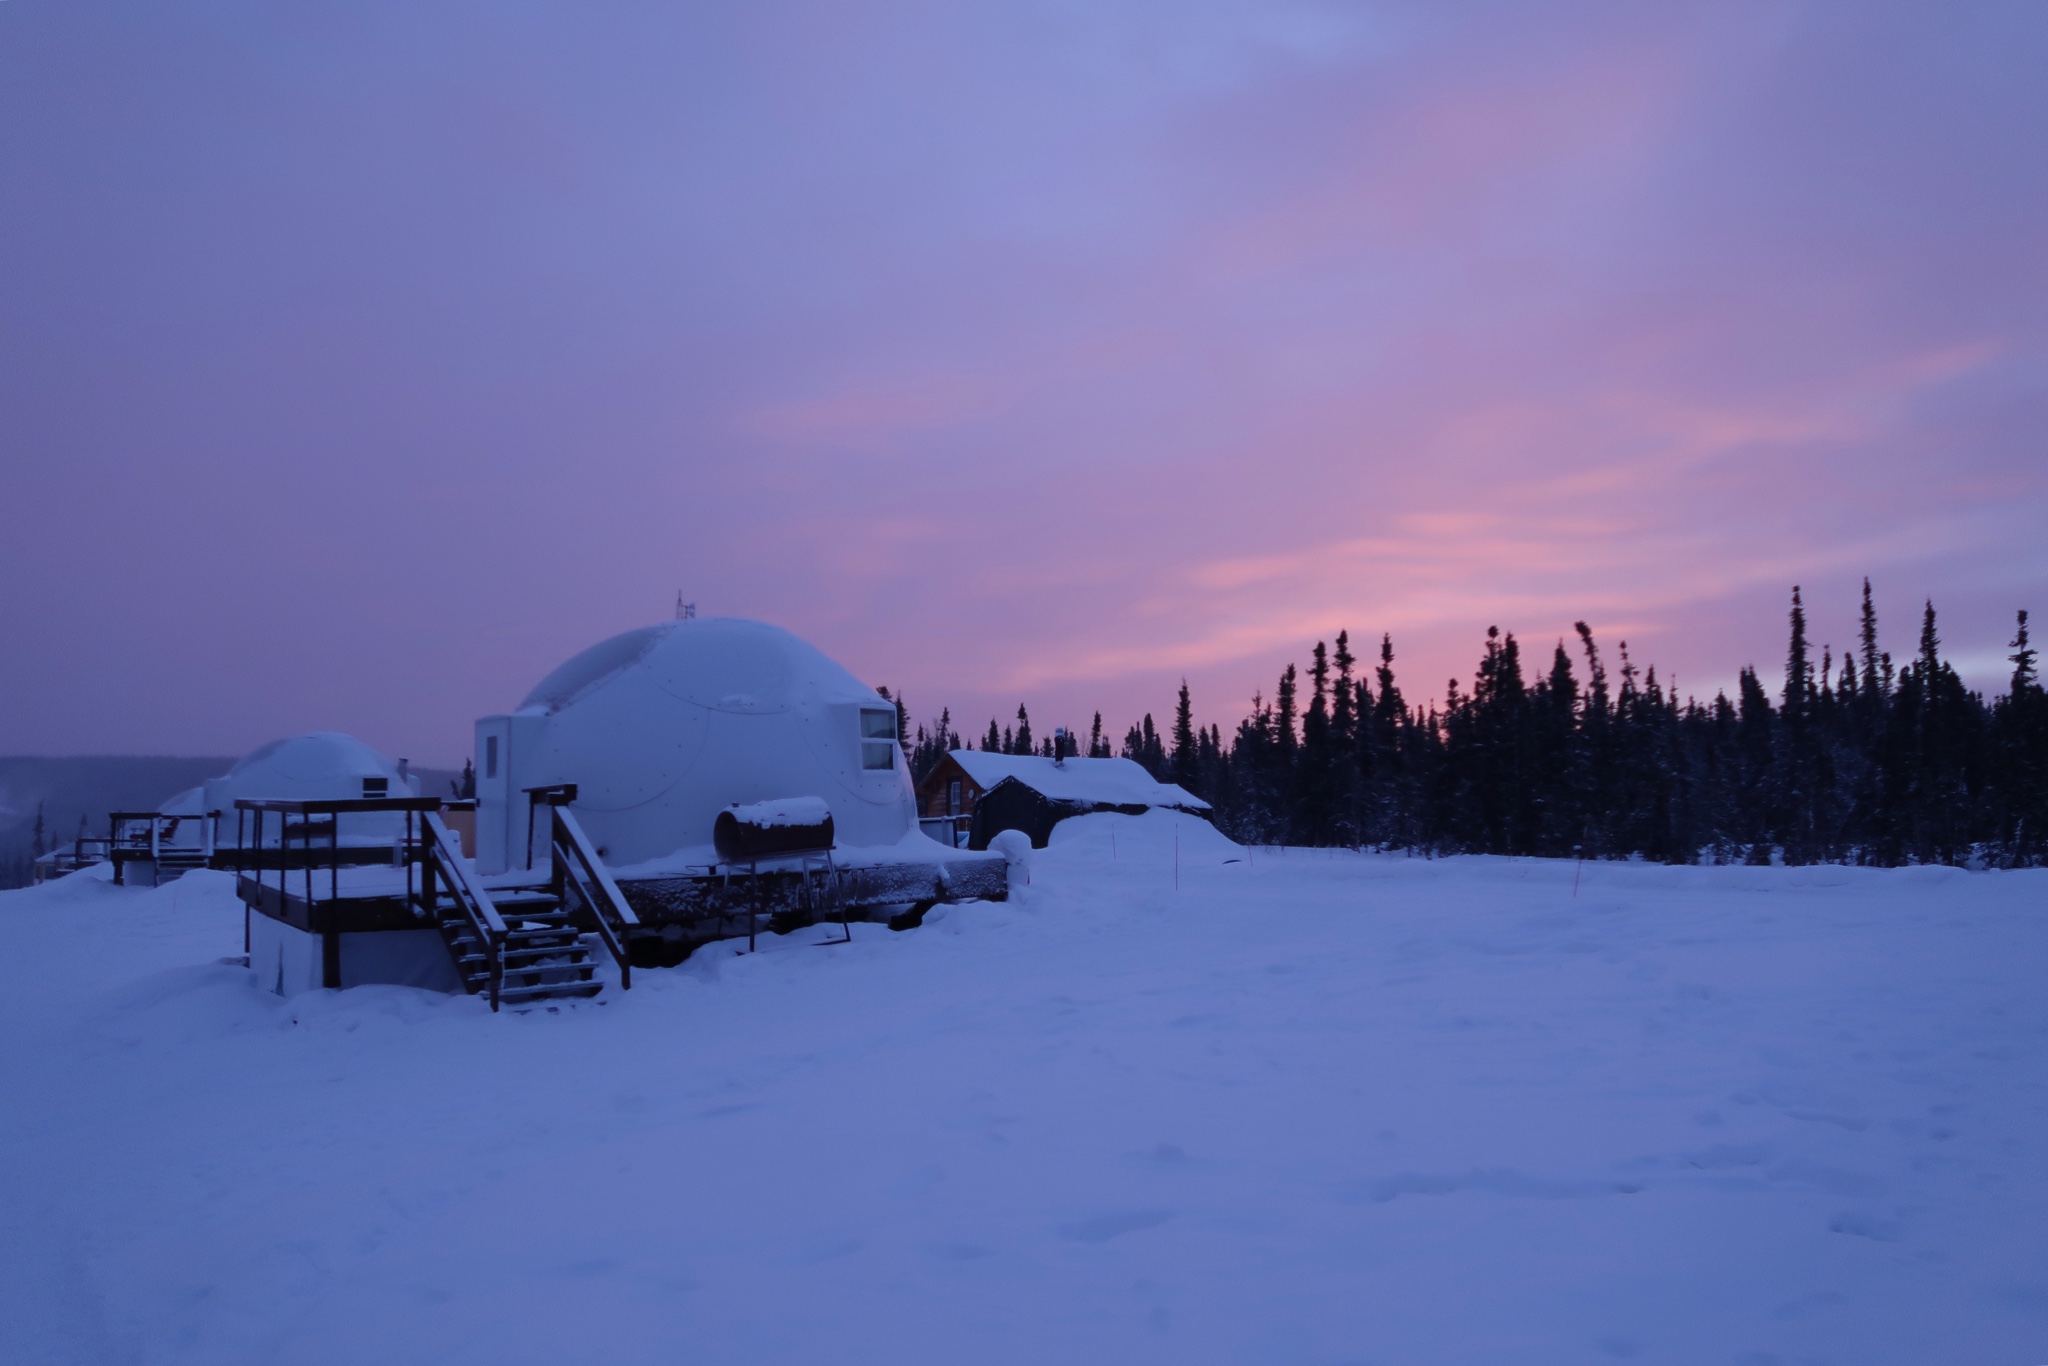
[{"left": 0, "top": 815, "right": 2048, "bottom": 1366}]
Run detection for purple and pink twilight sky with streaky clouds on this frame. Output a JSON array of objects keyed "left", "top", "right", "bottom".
[{"left": 0, "top": 0, "right": 2048, "bottom": 762}]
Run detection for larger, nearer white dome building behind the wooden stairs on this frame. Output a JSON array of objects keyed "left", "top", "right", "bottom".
[{"left": 475, "top": 616, "right": 918, "bottom": 872}]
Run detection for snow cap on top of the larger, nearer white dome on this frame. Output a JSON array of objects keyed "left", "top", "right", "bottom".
[{"left": 520, "top": 616, "right": 874, "bottom": 715}]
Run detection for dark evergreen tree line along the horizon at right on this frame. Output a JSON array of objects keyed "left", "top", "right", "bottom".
[{"left": 905, "top": 580, "right": 2048, "bottom": 866}]
